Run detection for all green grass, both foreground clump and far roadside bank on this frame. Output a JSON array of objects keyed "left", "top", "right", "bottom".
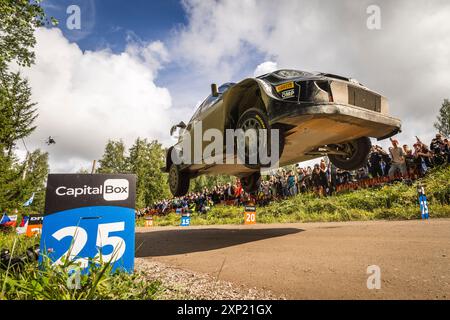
[{"left": 4, "top": 167, "right": 450, "bottom": 300}]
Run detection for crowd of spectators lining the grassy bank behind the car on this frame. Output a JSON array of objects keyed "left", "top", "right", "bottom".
[{"left": 138, "top": 134, "right": 450, "bottom": 215}]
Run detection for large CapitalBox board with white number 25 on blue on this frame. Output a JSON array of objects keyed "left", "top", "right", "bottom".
[{"left": 40, "top": 174, "right": 136, "bottom": 272}]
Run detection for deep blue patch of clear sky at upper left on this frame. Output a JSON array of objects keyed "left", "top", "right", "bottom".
[{"left": 43, "top": 0, "right": 186, "bottom": 52}]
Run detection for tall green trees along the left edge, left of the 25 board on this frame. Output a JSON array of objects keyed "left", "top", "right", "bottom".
[{"left": 0, "top": 0, "right": 49, "bottom": 211}]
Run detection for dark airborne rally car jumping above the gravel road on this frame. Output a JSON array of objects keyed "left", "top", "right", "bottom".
[{"left": 164, "top": 70, "right": 401, "bottom": 196}]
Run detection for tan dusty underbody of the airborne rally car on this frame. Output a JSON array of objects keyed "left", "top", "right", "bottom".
[{"left": 181, "top": 103, "right": 399, "bottom": 177}]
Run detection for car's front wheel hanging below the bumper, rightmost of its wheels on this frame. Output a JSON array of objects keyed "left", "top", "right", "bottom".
[{"left": 328, "top": 137, "right": 372, "bottom": 171}]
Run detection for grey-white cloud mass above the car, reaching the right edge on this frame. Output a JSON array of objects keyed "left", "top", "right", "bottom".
[{"left": 172, "top": 0, "right": 450, "bottom": 154}]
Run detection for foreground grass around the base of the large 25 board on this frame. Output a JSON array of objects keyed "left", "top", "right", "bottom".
[{"left": 0, "top": 233, "right": 164, "bottom": 300}]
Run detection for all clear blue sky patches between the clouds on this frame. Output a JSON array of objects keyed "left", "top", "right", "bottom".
[{"left": 43, "top": 0, "right": 264, "bottom": 109}]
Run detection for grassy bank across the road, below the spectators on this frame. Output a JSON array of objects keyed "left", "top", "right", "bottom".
[{"left": 137, "top": 166, "right": 450, "bottom": 226}]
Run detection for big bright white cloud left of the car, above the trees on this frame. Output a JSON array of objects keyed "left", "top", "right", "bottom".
[{"left": 15, "top": 29, "right": 172, "bottom": 172}]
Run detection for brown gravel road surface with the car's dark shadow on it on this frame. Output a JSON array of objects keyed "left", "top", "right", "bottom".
[{"left": 136, "top": 219, "right": 450, "bottom": 299}]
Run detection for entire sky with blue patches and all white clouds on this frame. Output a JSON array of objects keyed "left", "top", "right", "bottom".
[{"left": 22, "top": 0, "right": 450, "bottom": 172}]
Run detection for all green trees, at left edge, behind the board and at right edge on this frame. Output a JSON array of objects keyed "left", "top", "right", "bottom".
[{"left": 0, "top": 0, "right": 450, "bottom": 212}]
